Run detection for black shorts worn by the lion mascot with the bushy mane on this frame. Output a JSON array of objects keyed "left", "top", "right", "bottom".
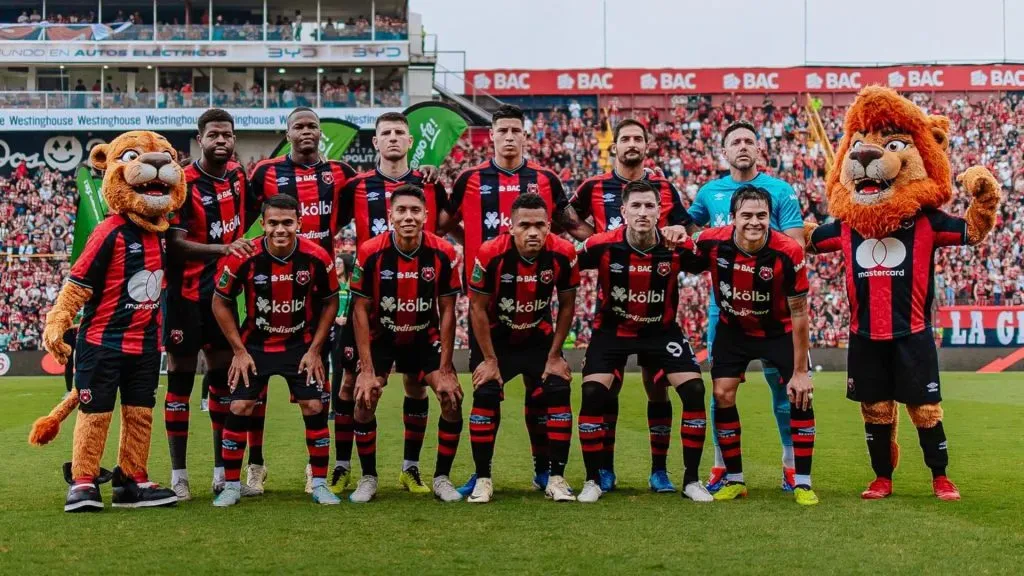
[{"left": 846, "top": 330, "right": 942, "bottom": 404}]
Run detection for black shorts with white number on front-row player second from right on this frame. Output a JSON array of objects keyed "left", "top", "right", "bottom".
[{"left": 583, "top": 326, "right": 700, "bottom": 381}]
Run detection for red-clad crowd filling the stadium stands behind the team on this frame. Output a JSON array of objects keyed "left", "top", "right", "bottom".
[{"left": 0, "top": 93, "right": 1024, "bottom": 351}]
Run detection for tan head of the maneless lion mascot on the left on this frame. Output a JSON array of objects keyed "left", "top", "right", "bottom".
[{"left": 89, "top": 130, "right": 185, "bottom": 232}]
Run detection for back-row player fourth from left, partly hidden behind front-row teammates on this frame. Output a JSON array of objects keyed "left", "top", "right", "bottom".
[{"left": 443, "top": 105, "right": 594, "bottom": 494}]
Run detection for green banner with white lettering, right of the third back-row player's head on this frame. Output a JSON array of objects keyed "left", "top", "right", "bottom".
[{"left": 404, "top": 101, "right": 469, "bottom": 170}]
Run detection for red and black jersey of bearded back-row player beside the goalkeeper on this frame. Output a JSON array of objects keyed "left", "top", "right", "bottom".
[{"left": 570, "top": 170, "right": 693, "bottom": 233}]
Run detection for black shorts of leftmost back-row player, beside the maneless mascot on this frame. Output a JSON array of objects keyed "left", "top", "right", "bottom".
[{"left": 164, "top": 291, "right": 232, "bottom": 356}]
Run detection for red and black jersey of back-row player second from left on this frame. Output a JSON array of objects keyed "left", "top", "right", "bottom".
[{"left": 246, "top": 155, "right": 355, "bottom": 251}]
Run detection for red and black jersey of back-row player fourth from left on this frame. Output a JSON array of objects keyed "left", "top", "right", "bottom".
[{"left": 445, "top": 160, "right": 568, "bottom": 278}]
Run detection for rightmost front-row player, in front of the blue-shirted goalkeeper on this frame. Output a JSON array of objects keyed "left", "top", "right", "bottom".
[{"left": 684, "top": 186, "right": 818, "bottom": 505}]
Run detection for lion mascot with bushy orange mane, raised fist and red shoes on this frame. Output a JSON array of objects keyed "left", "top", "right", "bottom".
[{"left": 806, "top": 86, "right": 1000, "bottom": 500}]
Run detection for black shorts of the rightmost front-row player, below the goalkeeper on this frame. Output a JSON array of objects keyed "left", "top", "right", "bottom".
[{"left": 711, "top": 322, "right": 794, "bottom": 383}]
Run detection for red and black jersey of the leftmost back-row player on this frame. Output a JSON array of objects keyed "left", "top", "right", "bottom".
[{"left": 167, "top": 157, "right": 247, "bottom": 302}]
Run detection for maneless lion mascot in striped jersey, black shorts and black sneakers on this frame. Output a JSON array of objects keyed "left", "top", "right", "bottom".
[{"left": 29, "top": 131, "right": 185, "bottom": 511}]
